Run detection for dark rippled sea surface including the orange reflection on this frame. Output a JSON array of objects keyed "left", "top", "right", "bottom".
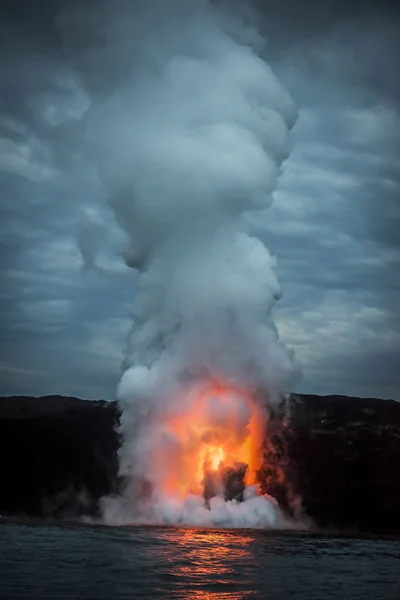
[{"left": 0, "top": 520, "right": 400, "bottom": 600}]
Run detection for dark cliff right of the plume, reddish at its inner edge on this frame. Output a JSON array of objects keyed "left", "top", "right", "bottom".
[{"left": 261, "top": 394, "right": 400, "bottom": 533}]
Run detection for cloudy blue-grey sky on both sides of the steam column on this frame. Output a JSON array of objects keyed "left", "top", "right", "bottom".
[{"left": 0, "top": 0, "right": 400, "bottom": 400}]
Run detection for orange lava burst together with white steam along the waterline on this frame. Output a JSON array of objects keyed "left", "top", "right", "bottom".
[{"left": 104, "top": 381, "right": 292, "bottom": 528}]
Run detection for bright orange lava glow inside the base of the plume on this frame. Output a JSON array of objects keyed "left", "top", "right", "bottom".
[{"left": 155, "top": 383, "right": 266, "bottom": 497}]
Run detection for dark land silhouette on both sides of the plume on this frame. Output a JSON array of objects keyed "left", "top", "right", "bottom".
[{"left": 0, "top": 394, "right": 400, "bottom": 534}]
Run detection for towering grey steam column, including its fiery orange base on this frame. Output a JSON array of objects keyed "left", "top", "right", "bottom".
[{"left": 60, "top": 0, "right": 296, "bottom": 527}]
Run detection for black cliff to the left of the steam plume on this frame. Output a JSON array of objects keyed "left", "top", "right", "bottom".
[{"left": 0, "top": 396, "right": 119, "bottom": 517}]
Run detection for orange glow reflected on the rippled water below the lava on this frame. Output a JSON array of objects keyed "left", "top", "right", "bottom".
[{"left": 162, "top": 529, "right": 255, "bottom": 600}]
